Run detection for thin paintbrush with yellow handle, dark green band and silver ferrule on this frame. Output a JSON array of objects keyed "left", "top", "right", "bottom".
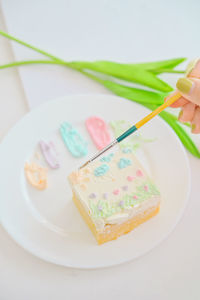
[{"left": 79, "top": 93, "right": 181, "bottom": 169}]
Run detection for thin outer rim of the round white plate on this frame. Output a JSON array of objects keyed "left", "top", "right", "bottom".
[{"left": 0, "top": 93, "right": 191, "bottom": 270}]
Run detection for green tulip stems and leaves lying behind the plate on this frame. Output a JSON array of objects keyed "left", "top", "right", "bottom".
[{"left": 0, "top": 31, "right": 200, "bottom": 158}]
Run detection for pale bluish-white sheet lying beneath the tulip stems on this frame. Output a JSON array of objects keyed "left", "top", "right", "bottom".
[{"left": 2, "top": 0, "right": 200, "bottom": 107}]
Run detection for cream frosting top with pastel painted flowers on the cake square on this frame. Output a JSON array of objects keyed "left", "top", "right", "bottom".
[{"left": 69, "top": 150, "right": 160, "bottom": 230}]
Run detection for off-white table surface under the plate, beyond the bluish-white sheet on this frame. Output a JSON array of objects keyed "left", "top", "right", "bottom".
[{"left": 0, "top": 1, "right": 200, "bottom": 300}]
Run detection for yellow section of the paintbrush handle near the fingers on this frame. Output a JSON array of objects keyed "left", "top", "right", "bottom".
[{"left": 135, "top": 93, "right": 181, "bottom": 129}]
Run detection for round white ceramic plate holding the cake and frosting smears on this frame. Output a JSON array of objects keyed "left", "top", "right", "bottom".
[{"left": 0, "top": 95, "right": 190, "bottom": 268}]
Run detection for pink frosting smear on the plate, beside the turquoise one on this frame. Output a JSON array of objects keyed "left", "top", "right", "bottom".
[{"left": 85, "top": 117, "right": 111, "bottom": 150}]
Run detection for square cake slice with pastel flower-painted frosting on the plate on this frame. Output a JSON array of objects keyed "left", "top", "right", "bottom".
[{"left": 68, "top": 148, "right": 160, "bottom": 244}]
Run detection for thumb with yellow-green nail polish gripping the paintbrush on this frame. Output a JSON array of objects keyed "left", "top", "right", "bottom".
[{"left": 176, "top": 77, "right": 200, "bottom": 106}]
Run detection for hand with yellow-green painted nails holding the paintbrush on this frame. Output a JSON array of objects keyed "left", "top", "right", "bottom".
[{"left": 166, "top": 59, "right": 200, "bottom": 133}]
